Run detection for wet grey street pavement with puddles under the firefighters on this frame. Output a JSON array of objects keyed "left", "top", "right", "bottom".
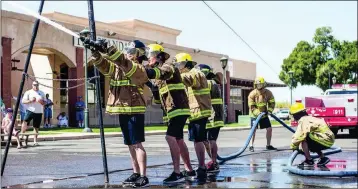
[{"left": 1, "top": 128, "right": 358, "bottom": 188}]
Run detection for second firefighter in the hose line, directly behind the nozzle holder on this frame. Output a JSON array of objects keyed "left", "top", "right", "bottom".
[{"left": 146, "top": 44, "right": 195, "bottom": 183}]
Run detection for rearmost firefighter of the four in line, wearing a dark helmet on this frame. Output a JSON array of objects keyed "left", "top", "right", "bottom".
[{"left": 198, "top": 64, "right": 224, "bottom": 173}]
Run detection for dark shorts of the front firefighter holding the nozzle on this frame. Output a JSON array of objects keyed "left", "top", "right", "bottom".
[{"left": 119, "top": 114, "right": 145, "bottom": 145}]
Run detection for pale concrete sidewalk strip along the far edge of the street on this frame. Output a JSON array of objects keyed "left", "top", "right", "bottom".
[{"left": 25, "top": 125, "right": 288, "bottom": 142}]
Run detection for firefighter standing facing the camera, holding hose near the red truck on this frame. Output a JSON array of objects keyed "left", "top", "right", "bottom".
[{"left": 248, "top": 77, "right": 276, "bottom": 152}]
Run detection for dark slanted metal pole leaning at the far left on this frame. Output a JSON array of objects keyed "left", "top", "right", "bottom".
[{"left": 1, "top": 0, "right": 45, "bottom": 176}]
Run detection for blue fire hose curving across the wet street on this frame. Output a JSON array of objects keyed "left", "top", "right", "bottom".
[{"left": 218, "top": 113, "right": 358, "bottom": 177}]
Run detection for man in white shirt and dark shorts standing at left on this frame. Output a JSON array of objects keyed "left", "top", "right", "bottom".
[{"left": 21, "top": 81, "right": 45, "bottom": 146}]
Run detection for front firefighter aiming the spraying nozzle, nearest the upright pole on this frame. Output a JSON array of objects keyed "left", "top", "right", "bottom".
[{"left": 84, "top": 39, "right": 149, "bottom": 187}]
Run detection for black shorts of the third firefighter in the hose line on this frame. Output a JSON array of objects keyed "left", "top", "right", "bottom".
[{"left": 189, "top": 117, "right": 208, "bottom": 142}]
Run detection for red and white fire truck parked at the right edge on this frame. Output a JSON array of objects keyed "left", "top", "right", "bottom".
[{"left": 291, "top": 84, "right": 358, "bottom": 137}]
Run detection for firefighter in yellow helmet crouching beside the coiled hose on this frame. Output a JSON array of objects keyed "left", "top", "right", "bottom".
[{"left": 290, "top": 103, "right": 335, "bottom": 166}]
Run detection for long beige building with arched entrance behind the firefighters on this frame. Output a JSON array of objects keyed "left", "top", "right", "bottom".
[{"left": 1, "top": 10, "right": 285, "bottom": 125}]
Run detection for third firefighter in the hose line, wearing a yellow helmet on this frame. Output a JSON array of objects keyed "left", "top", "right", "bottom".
[{"left": 173, "top": 53, "right": 211, "bottom": 180}]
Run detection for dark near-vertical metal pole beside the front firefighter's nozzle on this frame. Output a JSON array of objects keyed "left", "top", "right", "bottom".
[{"left": 87, "top": 0, "right": 109, "bottom": 183}]
